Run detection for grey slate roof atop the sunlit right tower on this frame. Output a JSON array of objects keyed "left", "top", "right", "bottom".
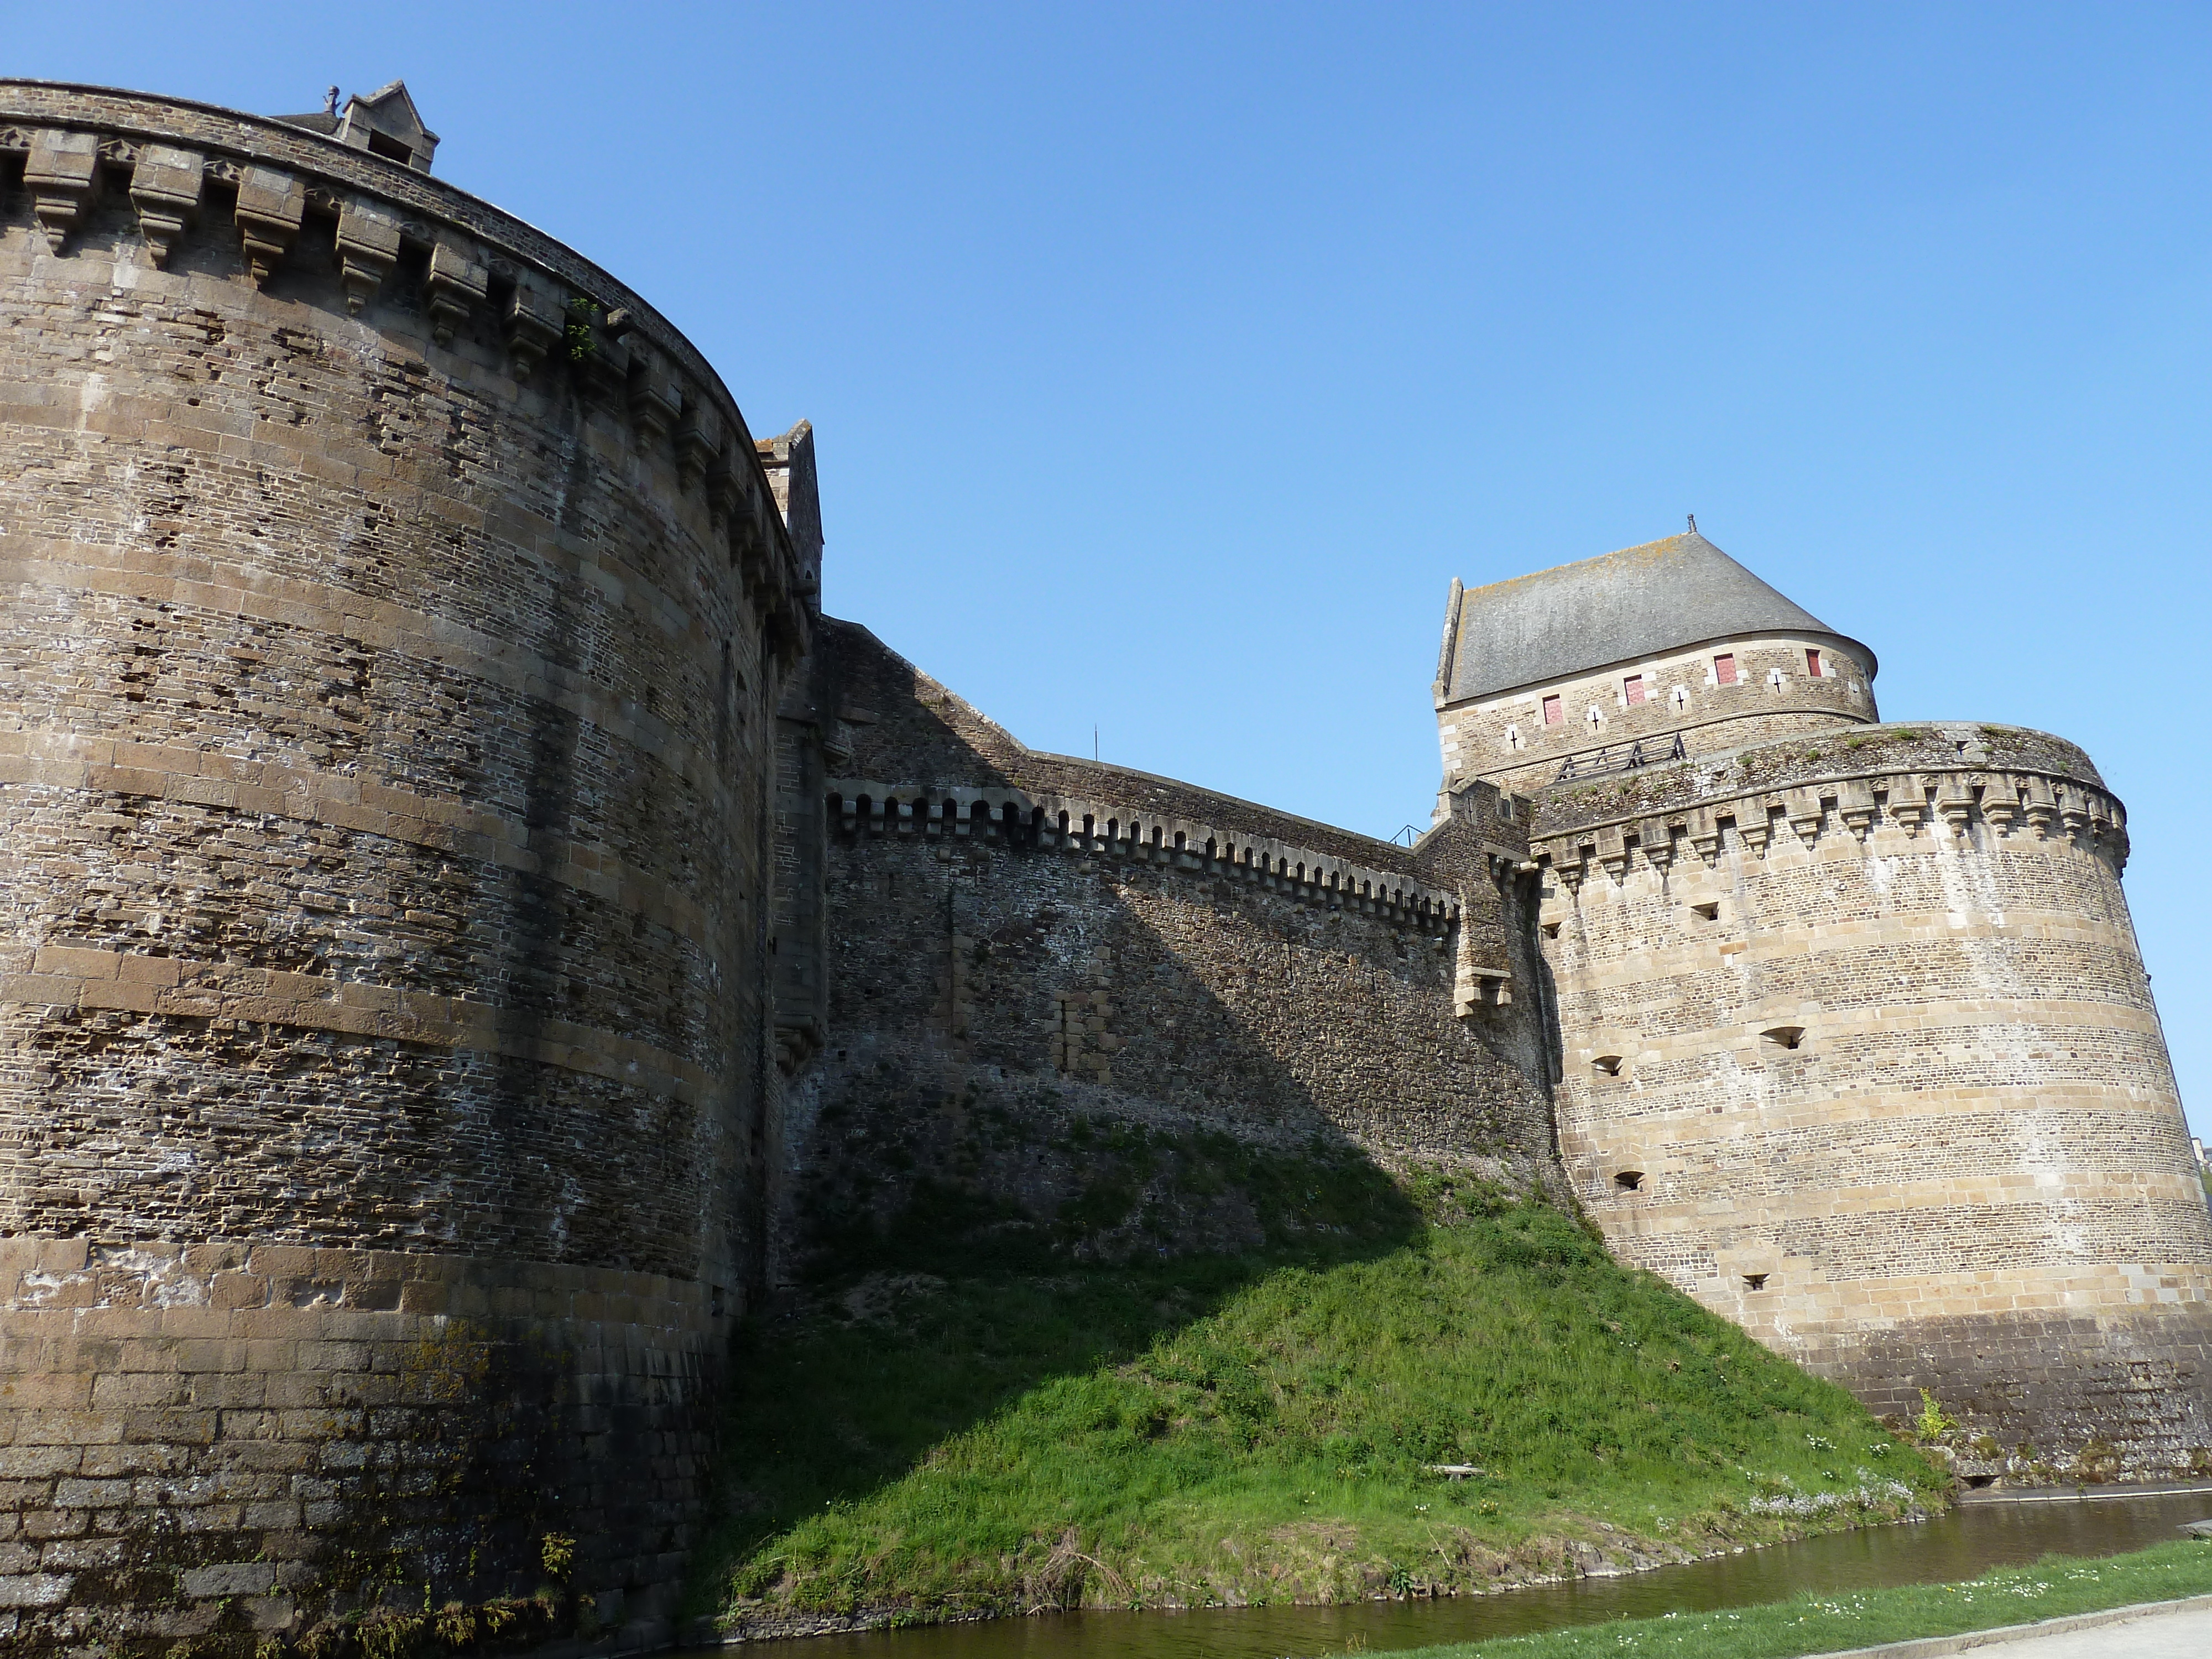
[{"left": 1438, "top": 531, "right": 1874, "bottom": 703}]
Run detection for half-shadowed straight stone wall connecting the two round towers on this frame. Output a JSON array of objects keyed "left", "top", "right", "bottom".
[{"left": 779, "top": 622, "right": 1551, "bottom": 1272}]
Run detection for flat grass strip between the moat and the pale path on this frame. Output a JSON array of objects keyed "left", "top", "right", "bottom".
[{"left": 1398, "top": 1542, "right": 2212, "bottom": 1659}]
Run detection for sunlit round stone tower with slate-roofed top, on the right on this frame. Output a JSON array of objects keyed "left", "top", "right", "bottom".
[{"left": 1438, "top": 533, "right": 2212, "bottom": 1480}]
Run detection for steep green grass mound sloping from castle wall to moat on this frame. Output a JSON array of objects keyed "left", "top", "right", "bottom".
[{"left": 695, "top": 1166, "right": 1944, "bottom": 1630}]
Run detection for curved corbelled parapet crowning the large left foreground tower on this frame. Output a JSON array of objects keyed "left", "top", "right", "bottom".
[{"left": 0, "top": 80, "right": 818, "bottom": 668}]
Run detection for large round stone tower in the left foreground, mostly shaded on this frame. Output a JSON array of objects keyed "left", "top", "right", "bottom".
[{"left": 0, "top": 82, "right": 818, "bottom": 1655}]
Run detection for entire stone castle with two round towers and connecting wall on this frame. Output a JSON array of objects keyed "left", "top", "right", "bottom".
[{"left": 0, "top": 82, "right": 2212, "bottom": 1655}]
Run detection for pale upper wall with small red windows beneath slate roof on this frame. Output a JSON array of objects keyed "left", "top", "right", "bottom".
[{"left": 1436, "top": 635, "right": 1880, "bottom": 792}]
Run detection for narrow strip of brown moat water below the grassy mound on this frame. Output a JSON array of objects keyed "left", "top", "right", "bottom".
[{"left": 684, "top": 1491, "right": 2212, "bottom": 1659}]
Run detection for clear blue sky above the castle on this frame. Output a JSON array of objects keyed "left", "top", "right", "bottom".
[{"left": 7, "top": 4, "right": 2212, "bottom": 1130}]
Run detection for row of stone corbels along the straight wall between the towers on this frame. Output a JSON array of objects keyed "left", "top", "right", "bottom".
[{"left": 827, "top": 779, "right": 1460, "bottom": 933}]
